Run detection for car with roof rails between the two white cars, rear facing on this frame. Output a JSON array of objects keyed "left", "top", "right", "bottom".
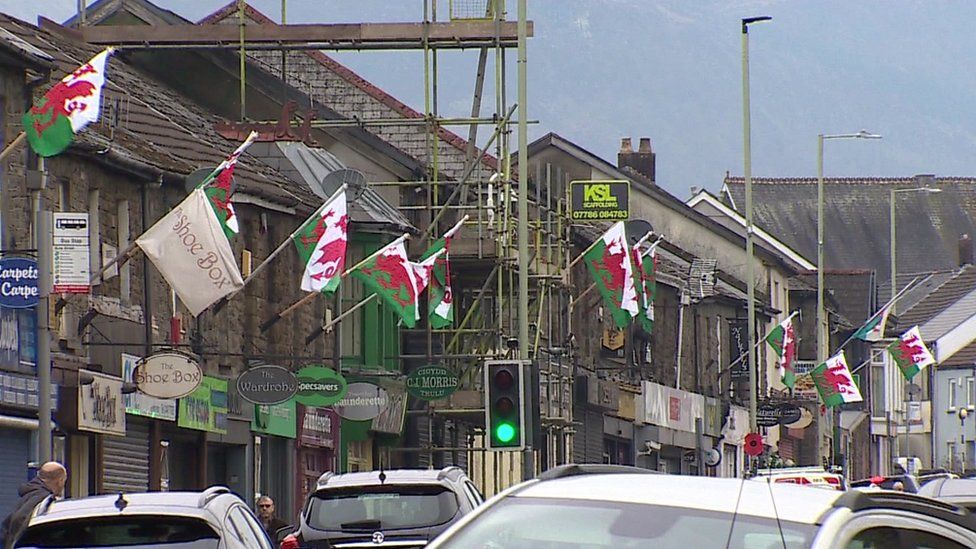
[{"left": 281, "top": 467, "right": 484, "bottom": 549}]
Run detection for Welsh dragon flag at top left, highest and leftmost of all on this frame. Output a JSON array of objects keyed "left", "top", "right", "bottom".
[{"left": 23, "top": 48, "right": 114, "bottom": 157}]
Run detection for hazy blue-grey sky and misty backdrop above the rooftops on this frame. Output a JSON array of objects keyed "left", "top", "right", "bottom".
[{"left": 0, "top": 0, "right": 976, "bottom": 198}]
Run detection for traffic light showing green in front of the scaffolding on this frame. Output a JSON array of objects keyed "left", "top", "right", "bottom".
[{"left": 484, "top": 360, "right": 525, "bottom": 450}]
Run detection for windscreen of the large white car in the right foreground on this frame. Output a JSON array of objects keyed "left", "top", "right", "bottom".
[{"left": 444, "top": 497, "right": 816, "bottom": 549}]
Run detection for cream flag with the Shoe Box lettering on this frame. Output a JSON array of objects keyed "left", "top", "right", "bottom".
[{"left": 136, "top": 189, "right": 244, "bottom": 316}]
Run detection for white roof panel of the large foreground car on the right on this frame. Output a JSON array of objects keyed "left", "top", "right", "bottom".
[{"left": 511, "top": 473, "right": 843, "bottom": 524}]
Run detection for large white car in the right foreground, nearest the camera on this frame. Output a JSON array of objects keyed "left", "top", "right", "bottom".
[{"left": 428, "top": 465, "right": 976, "bottom": 549}]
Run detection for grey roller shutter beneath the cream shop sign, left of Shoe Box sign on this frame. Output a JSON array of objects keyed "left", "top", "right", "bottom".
[{"left": 102, "top": 416, "right": 149, "bottom": 494}]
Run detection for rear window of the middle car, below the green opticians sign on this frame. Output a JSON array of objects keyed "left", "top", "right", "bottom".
[{"left": 307, "top": 484, "right": 458, "bottom": 531}]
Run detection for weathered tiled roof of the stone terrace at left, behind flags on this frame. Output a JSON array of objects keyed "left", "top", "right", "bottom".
[{"left": 0, "top": 12, "right": 409, "bottom": 229}]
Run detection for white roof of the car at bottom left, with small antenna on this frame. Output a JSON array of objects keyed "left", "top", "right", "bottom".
[{"left": 30, "top": 487, "right": 242, "bottom": 526}]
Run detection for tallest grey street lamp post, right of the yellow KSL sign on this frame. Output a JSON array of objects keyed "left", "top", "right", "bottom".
[{"left": 742, "top": 15, "right": 772, "bottom": 433}]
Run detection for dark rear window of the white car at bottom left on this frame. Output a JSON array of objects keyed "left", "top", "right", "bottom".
[{"left": 15, "top": 515, "right": 220, "bottom": 549}]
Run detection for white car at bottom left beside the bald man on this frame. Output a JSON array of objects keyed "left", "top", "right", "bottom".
[{"left": 14, "top": 486, "right": 273, "bottom": 549}]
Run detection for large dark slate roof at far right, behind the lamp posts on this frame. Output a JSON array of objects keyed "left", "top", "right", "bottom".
[{"left": 723, "top": 176, "right": 976, "bottom": 285}]
